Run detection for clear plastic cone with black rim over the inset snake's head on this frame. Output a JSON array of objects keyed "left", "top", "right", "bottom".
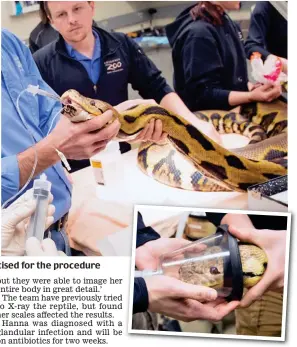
[{"left": 158, "top": 226, "right": 243, "bottom": 300}]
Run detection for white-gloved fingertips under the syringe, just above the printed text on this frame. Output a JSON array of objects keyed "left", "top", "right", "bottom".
[{"left": 26, "top": 237, "right": 66, "bottom": 257}]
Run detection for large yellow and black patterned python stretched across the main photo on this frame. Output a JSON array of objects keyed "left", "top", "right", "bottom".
[{"left": 61, "top": 90, "right": 287, "bottom": 191}]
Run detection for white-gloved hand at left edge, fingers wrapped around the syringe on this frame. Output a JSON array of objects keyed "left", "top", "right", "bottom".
[{"left": 1, "top": 189, "right": 55, "bottom": 256}]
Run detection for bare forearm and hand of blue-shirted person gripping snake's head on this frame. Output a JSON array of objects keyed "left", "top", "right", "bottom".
[{"left": 17, "top": 111, "right": 120, "bottom": 188}]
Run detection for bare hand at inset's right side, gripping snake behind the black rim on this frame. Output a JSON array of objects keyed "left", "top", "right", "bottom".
[{"left": 229, "top": 225, "right": 286, "bottom": 307}]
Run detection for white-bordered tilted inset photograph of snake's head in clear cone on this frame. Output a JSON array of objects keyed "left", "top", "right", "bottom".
[{"left": 128, "top": 205, "right": 291, "bottom": 341}]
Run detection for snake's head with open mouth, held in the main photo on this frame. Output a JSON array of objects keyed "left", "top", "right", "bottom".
[{"left": 61, "top": 89, "right": 118, "bottom": 122}]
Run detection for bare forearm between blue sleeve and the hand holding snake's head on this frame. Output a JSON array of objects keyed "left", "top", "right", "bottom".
[{"left": 17, "top": 135, "right": 60, "bottom": 188}]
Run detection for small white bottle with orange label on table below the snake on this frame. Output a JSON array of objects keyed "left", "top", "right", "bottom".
[{"left": 90, "top": 141, "right": 122, "bottom": 186}]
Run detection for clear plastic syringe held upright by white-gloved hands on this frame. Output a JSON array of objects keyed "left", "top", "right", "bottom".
[{"left": 27, "top": 173, "right": 51, "bottom": 241}]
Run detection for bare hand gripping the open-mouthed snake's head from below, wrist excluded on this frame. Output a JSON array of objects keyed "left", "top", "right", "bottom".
[{"left": 48, "top": 110, "right": 121, "bottom": 160}]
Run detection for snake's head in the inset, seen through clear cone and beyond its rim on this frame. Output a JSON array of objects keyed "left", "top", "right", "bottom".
[{"left": 179, "top": 244, "right": 268, "bottom": 288}]
